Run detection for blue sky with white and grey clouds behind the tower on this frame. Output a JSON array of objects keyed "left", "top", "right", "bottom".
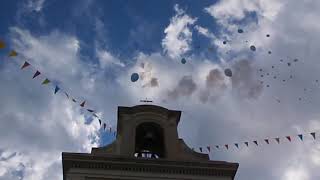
[{"left": 0, "top": 0, "right": 320, "bottom": 180}]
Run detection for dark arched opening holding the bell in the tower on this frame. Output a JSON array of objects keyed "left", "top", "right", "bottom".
[{"left": 134, "top": 122, "right": 165, "bottom": 158}]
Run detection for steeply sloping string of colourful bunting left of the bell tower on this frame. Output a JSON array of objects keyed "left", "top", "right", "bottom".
[{"left": 0, "top": 40, "right": 116, "bottom": 136}]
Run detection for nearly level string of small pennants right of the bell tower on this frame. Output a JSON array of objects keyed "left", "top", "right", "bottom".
[{"left": 193, "top": 131, "right": 319, "bottom": 153}]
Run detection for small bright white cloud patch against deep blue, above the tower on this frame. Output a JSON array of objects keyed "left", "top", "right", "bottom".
[{"left": 162, "top": 5, "right": 197, "bottom": 58}]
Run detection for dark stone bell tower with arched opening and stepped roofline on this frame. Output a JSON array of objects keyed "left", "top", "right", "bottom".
[{"left": 62, "top": 105, "right": 239, "bottom": 180}]
